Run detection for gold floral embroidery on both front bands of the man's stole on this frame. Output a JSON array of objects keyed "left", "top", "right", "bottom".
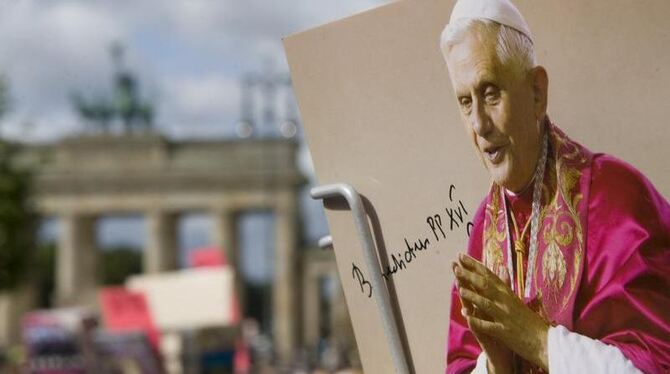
[{"left": 482, "top": 123, "right": 588, "bottom": 321}]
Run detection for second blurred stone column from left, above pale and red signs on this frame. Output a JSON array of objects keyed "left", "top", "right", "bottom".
[{"left": 143, "top": 211, "right": 177, "bottom": 273}]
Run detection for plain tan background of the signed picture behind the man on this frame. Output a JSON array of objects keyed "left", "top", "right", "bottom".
[{"left": 284, "top": 0, "right": 670, "bottom": 373}]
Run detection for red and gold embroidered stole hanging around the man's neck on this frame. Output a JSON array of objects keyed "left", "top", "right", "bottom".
[{"left": 483, "top": 124, "right": 592, "bottom": 328}]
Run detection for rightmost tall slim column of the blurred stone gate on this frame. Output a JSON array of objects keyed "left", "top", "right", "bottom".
[{"left": 272, "top": 190, "right": 300, "bottom": 362}]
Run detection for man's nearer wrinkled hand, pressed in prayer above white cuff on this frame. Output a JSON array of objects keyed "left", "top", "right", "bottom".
[{"left": 454, "top": 254, "right": 549, "bottom": 371}]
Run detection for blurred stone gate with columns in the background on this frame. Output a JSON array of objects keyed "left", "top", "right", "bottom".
[{"left": 0, "top": 69, "right": 355, "bottom": 363}]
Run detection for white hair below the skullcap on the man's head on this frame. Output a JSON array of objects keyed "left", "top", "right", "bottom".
[{"left": 440, "top": 18, "right": 537, "bottom": 73}]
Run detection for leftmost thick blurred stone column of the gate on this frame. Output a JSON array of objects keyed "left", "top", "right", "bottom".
[{"left": 56, "top": 214, "right": 98, "bottom": 306}]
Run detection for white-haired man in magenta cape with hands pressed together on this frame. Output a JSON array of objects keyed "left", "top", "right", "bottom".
[{"left": 440, "top": 0, "right": 670, "bottom": 373}]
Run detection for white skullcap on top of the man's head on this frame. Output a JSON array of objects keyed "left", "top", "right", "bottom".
[{"left": 447, "top": 0, "right": 533, "bottom": 42}]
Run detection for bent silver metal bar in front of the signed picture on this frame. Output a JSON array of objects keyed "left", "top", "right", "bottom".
[{"left": 310, "top": 183, "right": 409, "bottom": 374}]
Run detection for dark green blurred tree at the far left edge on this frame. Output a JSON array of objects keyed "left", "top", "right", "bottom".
[{"left": 0, "top": 78, "right": 35, "bottom": 291}]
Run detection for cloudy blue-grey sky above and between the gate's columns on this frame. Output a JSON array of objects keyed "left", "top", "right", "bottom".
[{"left": 0, "top": 0, "right": 386, "bottom": 270}]
